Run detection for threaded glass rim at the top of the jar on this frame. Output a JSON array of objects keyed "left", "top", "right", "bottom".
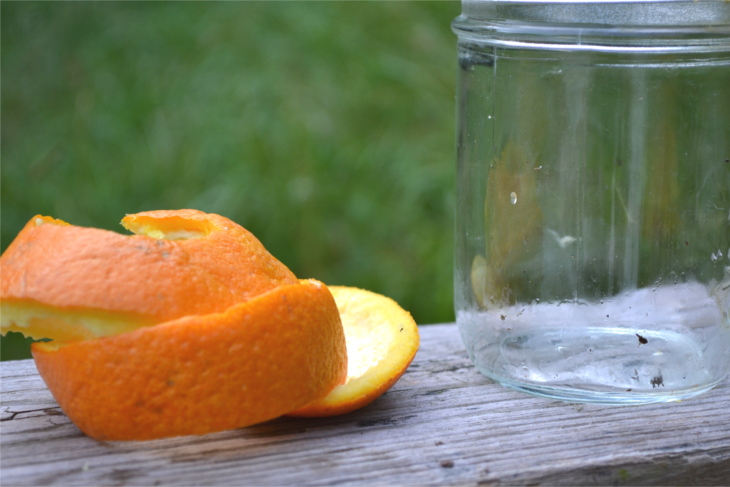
[{"left": 452, "top": 0, "right": 730, "bottom": 53}]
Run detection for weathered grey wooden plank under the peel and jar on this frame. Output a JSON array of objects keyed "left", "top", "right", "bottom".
[{"left": 0, "top": 325, "right": 730, "bottom": 486}]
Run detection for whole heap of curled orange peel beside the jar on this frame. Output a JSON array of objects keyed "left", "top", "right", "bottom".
[{"left": 0, "top": 210, "right": 418, "bottom": 440}]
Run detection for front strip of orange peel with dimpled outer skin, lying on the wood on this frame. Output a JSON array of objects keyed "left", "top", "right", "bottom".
[{"left": 32, "top": 280, "right": 347, "bottom": 440}]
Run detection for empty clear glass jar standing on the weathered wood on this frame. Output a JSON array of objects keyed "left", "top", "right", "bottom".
[{"left": 453, "top": 0, "right": 730, "bottom": 404}]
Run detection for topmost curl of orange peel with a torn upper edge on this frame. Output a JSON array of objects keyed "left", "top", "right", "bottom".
[{"left": 0, "top": 210, "right": 298, "bottom": 341}]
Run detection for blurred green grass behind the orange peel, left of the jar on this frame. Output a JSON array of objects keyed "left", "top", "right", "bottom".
[{"left": 0, "top": 1, "right": 460, "bottom": 359}]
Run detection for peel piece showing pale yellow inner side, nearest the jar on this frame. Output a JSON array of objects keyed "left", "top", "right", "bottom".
[{"left": 289, "top": 286, "right": 419, "bottom": 417}]
